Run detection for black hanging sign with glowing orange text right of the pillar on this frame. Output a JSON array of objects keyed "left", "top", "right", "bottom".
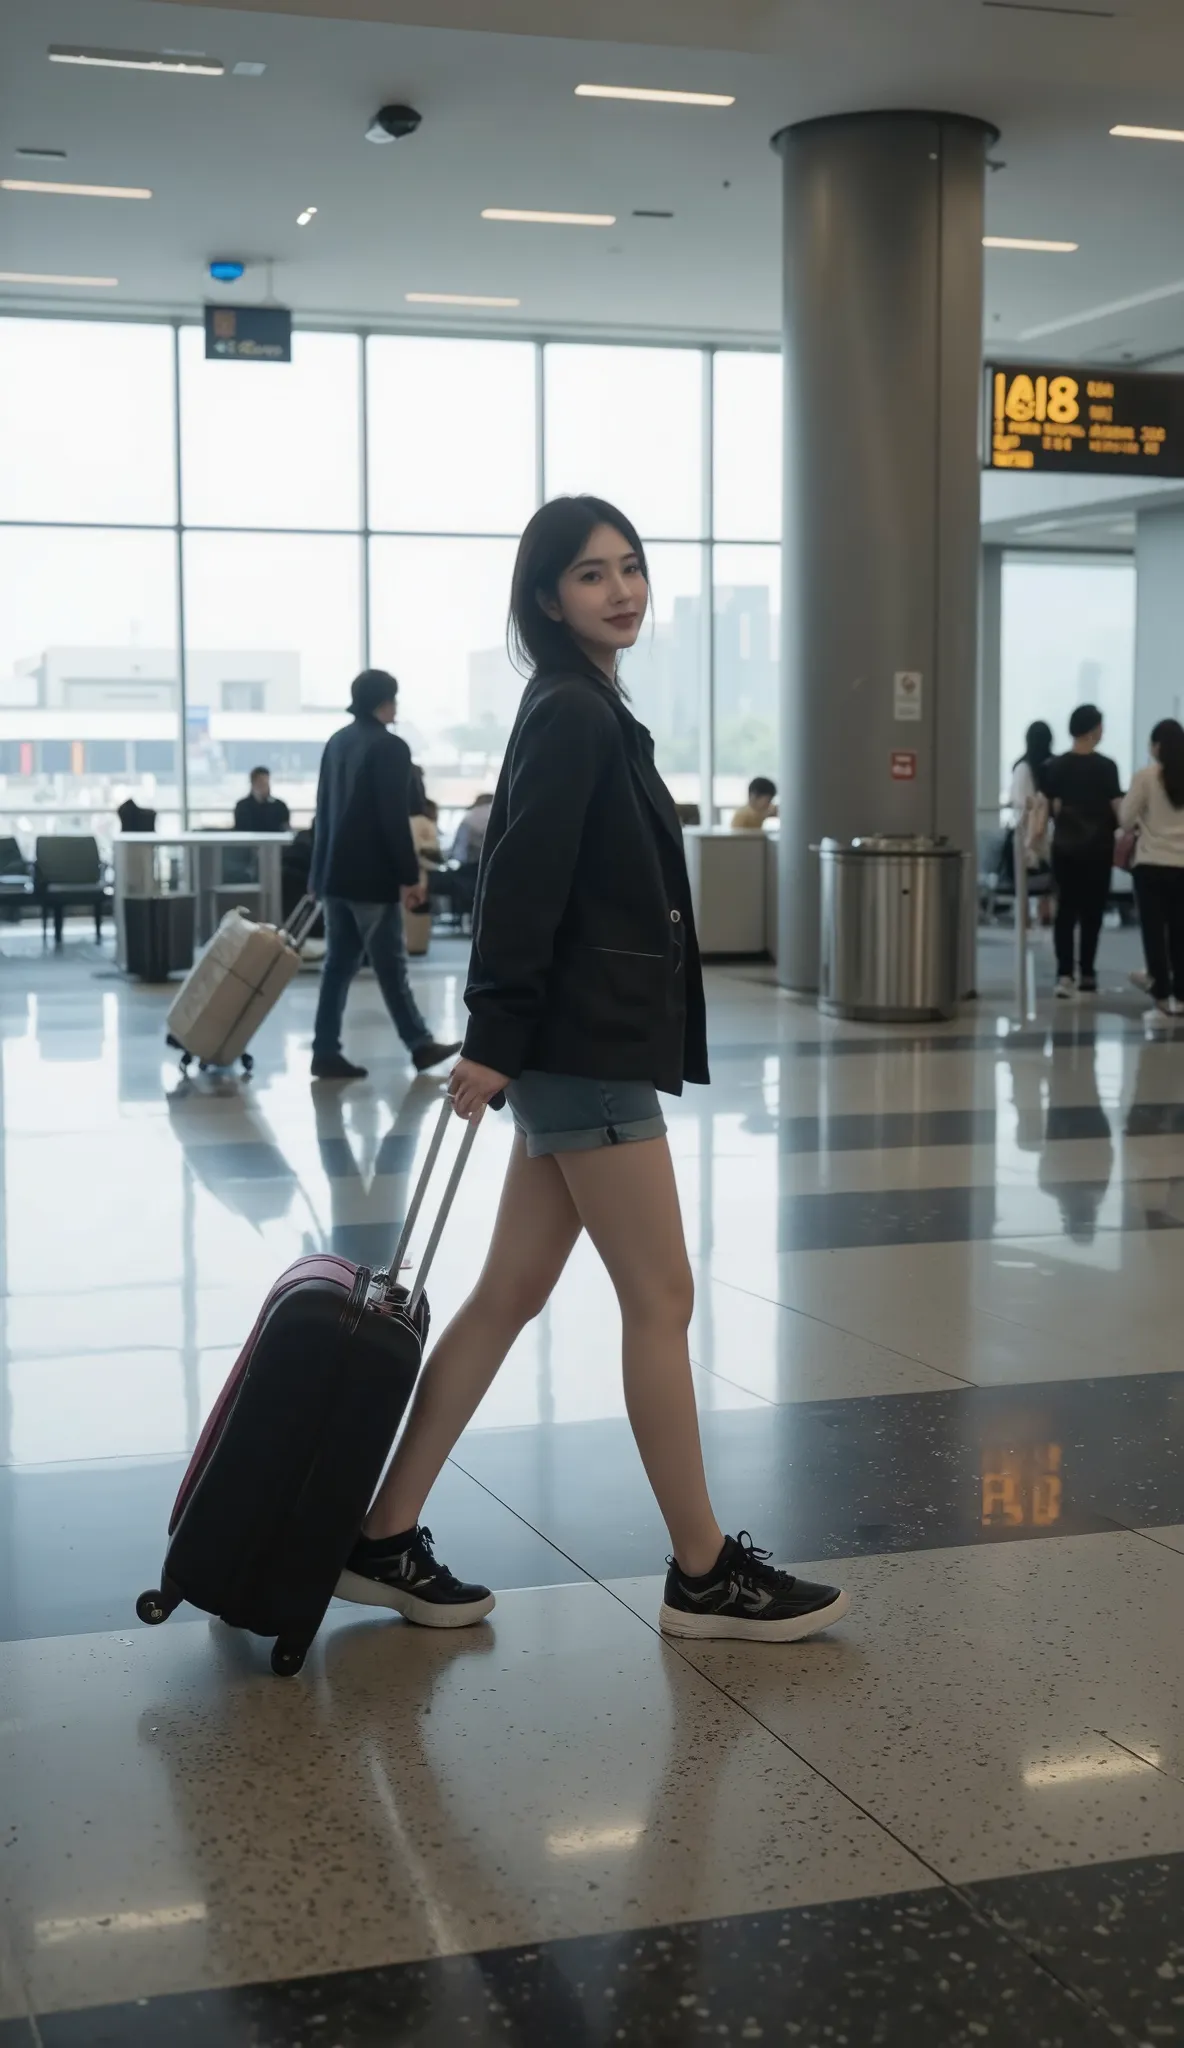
[{"left": 983, "top": 362, "right": 1184, "bottom": 477}]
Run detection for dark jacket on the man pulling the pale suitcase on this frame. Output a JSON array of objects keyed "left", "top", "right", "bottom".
[{"left": 309, "top": 713, "right": 420, "bottom": 903}]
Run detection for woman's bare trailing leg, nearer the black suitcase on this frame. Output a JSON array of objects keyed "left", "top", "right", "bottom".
[{"left": 365, "top": 1137, "right": 580, "bottom": 1538}]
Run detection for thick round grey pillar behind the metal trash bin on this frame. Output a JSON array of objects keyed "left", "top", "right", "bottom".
[{"left": 774, "top": 113, "right": 993, "bottom": 989}]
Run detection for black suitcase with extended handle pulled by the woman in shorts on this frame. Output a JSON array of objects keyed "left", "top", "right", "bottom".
[{"left": 135, "top": 1102, "right": 477, "bottom": 1677}]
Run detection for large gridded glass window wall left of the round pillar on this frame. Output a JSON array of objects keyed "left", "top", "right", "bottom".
[{"left": 0, "top": 317, "right": 780, "bottom": 852}]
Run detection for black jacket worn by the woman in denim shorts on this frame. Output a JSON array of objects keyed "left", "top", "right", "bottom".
[{"left": 465, "top": 676, "right": 709, "bottom": 1096}]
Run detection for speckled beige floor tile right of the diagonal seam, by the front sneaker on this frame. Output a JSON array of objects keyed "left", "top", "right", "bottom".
[{"left": 615, "top": 1532, "right": 1184, "bottom": 1884}]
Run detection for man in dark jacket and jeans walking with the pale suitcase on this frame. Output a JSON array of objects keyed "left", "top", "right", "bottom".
[{"left": 309, "top": 668, "right": 459, "bottom": 1081}]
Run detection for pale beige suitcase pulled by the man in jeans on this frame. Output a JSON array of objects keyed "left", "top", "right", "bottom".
[{"left": 168, "top": 897, "right": 318, "bottom": 1073}]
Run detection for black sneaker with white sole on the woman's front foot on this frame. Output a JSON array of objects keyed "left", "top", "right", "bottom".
[{"left": 658, "top": 1530, "right": 850, "bottom": 1642}]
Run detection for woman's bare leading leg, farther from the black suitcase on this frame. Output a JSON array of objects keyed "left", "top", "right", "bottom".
[{"left": 559, "top": 1139, "right": 723, "bottom": 1577}]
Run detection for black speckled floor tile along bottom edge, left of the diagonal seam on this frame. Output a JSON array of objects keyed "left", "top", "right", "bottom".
[{"left": 25, "top": 1890, "right": 1114, "bottom": 2048}]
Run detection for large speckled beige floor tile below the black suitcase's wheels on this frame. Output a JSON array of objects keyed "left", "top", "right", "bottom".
[{"left": 4, "top": 1585, "right": 928, "bottom": 2011}]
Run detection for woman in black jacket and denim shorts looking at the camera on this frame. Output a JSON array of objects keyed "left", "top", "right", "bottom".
[{"left": 338, "top": 498, "right": 848, "bottom": 1642}]
